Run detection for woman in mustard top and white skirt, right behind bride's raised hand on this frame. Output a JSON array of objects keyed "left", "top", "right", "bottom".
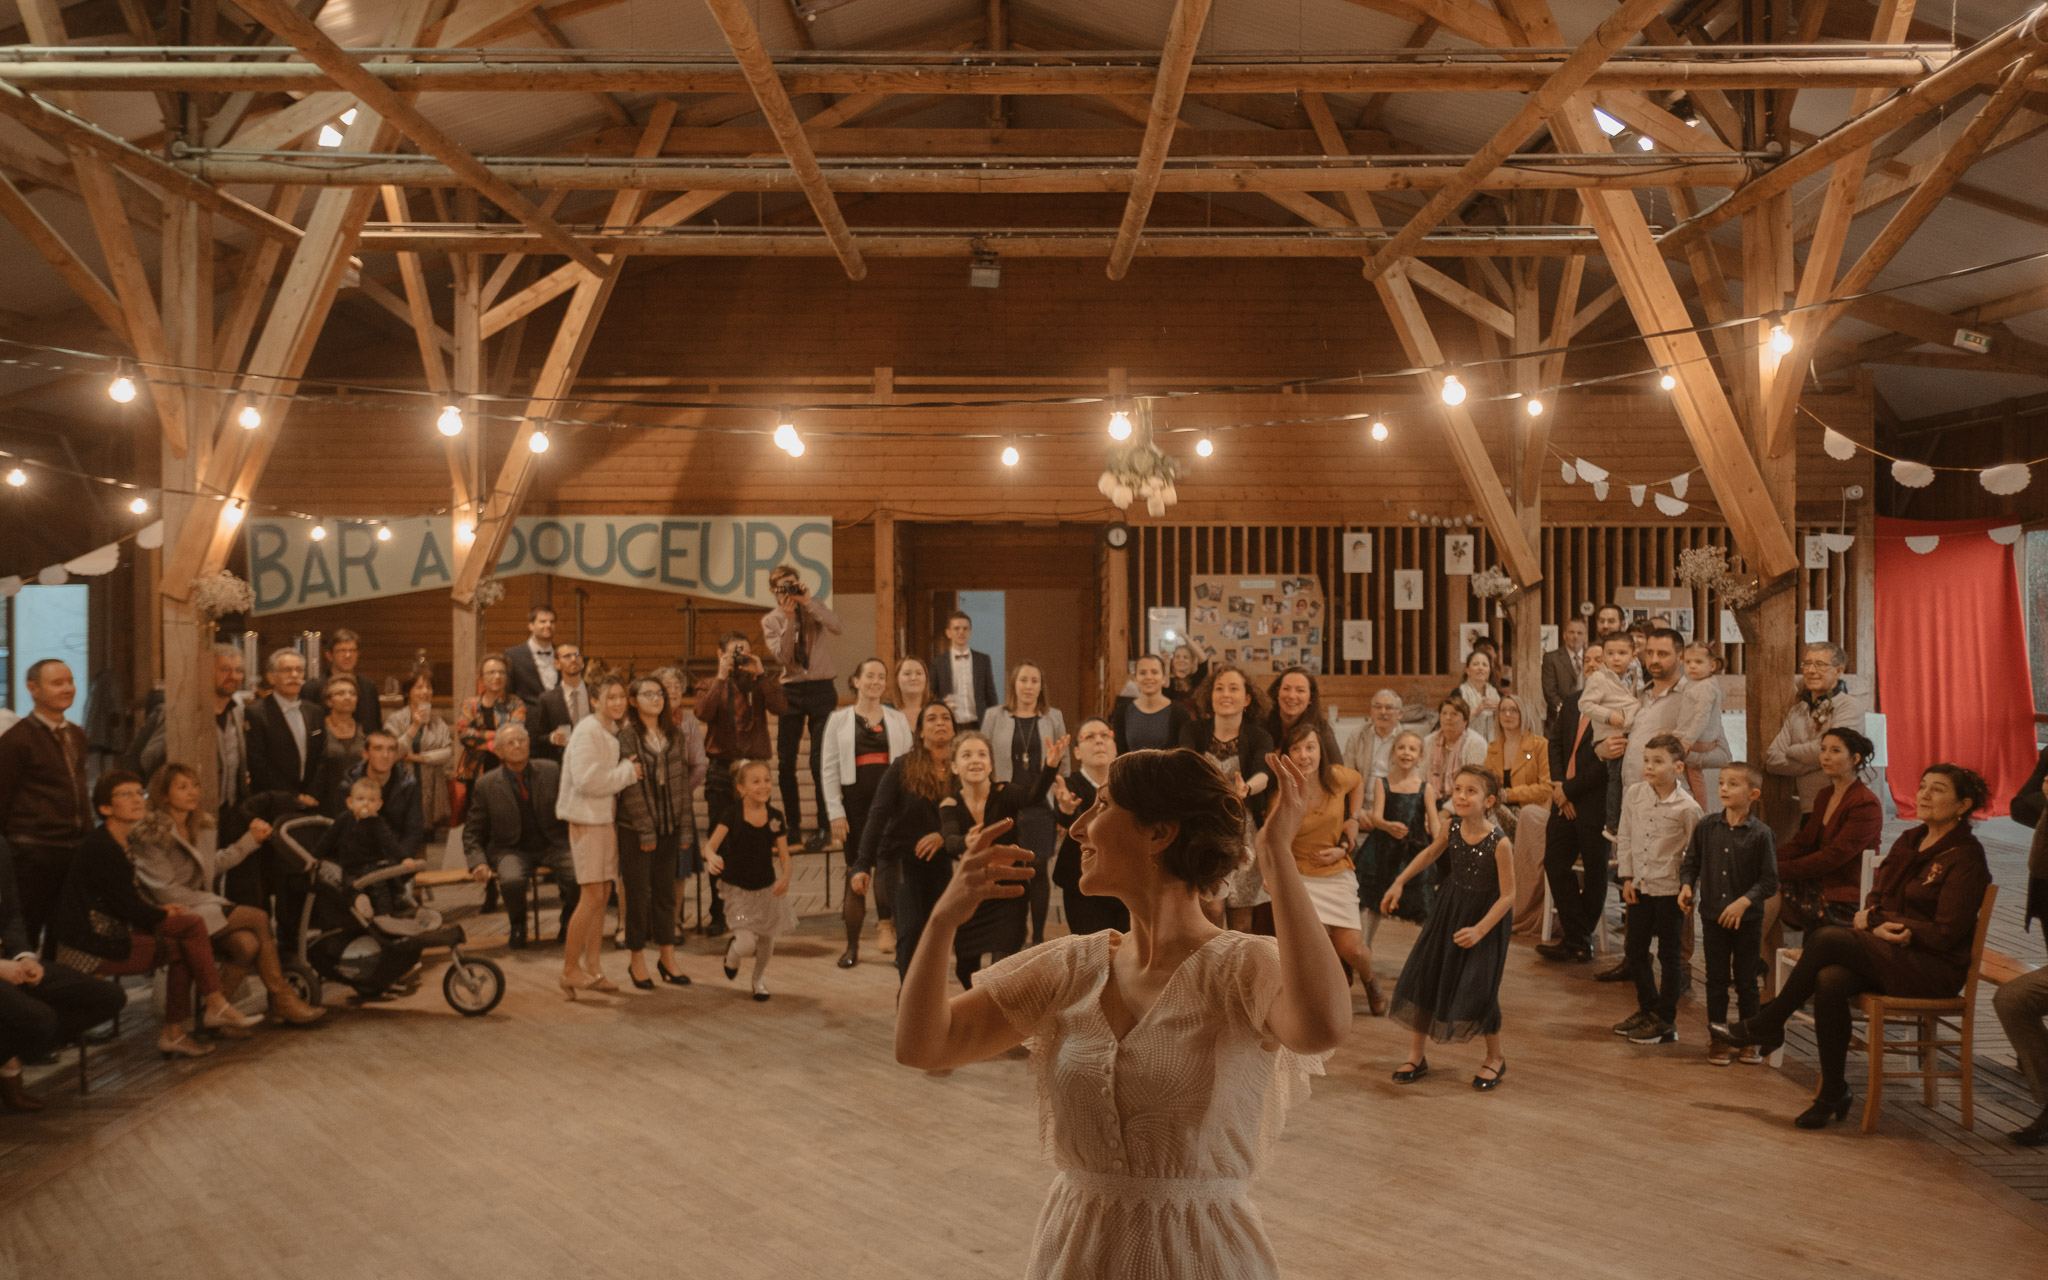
[{"left": 1280, "top": 717, "right": 1386, "bottom": 1018}]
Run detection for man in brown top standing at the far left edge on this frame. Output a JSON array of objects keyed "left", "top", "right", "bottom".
[{"left": 0, "top": 657, "right": 92, "bottom": 948}]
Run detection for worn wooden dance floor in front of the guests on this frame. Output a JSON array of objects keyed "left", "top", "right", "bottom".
[{"left": 0, "top": 858, "right": 2048, "bottom": 1280}]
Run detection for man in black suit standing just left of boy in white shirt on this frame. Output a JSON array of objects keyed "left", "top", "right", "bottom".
[{"left": 1536, "top": 649, "right": 1610, "bottom": 963}]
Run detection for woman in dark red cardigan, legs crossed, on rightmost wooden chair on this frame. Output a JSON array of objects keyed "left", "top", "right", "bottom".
[{"left": 1714, "top": 764, "right": 1991, "bottom": 1128}]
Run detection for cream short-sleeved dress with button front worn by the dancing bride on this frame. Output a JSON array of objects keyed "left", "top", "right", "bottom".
[{"left": 975, "top": 932, "right": 1327, "bottom": 1280}]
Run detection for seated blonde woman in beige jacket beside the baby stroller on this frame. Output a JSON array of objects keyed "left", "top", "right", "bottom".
[{"left": 129, "top": 764, "right": 326, "bottom": 1026}]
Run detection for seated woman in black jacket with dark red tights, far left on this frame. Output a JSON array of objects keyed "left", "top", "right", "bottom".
[{"left": 51, "top": 770, "right": 268, "bottom": 1057}]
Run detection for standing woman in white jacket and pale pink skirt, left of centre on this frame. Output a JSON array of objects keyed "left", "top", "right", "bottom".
[{"left": 555, "top": 676, "right": 639, "bottom": 999}]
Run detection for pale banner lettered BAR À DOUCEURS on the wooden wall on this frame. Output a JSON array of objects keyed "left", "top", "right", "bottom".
[{"left": 244, "top": 516, "right": 831, "bottom": 614}]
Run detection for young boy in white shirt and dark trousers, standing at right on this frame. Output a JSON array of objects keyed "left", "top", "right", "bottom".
[{"left": 1614, "top": 733, "right": 1702, "bottom": 1044}]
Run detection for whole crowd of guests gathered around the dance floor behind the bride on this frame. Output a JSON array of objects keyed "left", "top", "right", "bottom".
[{"left": 0, "top": 585, "right": 2048, "bottom": 1143}]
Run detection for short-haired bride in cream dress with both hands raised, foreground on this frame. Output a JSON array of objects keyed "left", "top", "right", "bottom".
[{"left": 895, "top": 752, "right": 1352, "bottom": 1280}]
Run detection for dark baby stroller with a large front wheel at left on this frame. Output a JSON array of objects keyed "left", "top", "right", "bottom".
[{"left": 272, "top": 815, "right": 506, "bottom": 1018}]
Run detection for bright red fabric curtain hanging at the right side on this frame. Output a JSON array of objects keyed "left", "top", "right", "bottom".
[{"left": 1876, "top": 516, "right": 2034, "bottom": 817}]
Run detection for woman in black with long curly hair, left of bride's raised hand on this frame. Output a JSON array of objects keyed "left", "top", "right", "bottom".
[{"left": 848, "top": 700, "right": 952, "bottom": 979}]
